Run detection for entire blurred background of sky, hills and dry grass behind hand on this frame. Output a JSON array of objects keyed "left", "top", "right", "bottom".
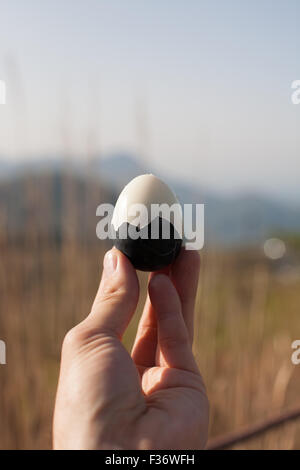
[{"left": 0, "top": 0, "right": 300, "bottom": 449}]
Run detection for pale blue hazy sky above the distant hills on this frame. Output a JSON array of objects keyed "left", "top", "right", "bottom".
[{"left": 0, "top": 0, "right": 300, "bottom": 200}]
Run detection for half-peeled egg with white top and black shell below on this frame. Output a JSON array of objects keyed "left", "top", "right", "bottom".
[{"left": 112, "top": 174, "right": 182, "bottom": 272}]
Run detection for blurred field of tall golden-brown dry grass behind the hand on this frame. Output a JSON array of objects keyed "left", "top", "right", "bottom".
[{"left": 0, "top": 172, "right": 300, "bottom": 449}]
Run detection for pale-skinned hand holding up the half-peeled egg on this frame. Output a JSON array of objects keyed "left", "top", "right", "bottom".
[{"left": 53, "top": 248, "right": 209, "bottom": 449}]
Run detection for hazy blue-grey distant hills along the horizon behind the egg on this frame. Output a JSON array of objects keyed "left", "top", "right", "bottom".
[{"left": 0, "top": 153, "right": 300, "bottom": 245}]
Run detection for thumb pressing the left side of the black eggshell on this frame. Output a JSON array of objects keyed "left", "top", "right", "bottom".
[{"left": 86, "top": 248, "right": 139, "bottom": 338}]
